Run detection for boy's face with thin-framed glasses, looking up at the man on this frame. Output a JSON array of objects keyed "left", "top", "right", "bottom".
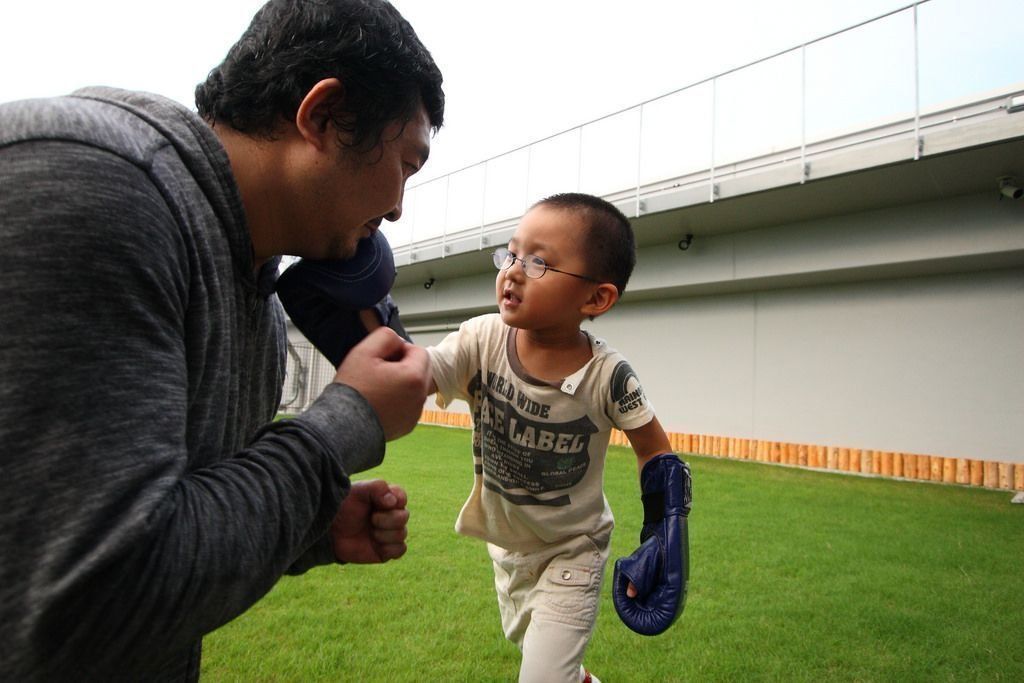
[{"left": 495, "top": 205, "right": 597, "bottom": 334}]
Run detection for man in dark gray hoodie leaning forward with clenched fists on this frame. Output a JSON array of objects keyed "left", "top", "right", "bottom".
[{"left": 0, "top": 0, "right": 444, "bottom": 680}]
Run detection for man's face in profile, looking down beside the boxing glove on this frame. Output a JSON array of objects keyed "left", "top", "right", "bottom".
[{"left": 295, "top": 106, "right": 430, "bottom": 259}]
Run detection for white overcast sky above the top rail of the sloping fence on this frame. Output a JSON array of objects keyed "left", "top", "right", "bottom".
[{"left": 0, "top": 0, "right": 933, "bottom": 181}]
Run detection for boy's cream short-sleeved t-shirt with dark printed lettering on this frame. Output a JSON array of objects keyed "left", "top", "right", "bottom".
[{"left": 427, "top": 313, "right": 654, "bottom": 552}]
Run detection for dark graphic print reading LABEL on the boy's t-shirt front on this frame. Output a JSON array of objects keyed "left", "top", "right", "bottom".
[{"left": 469, "top": 372, "right": 598, "bottom": 506}]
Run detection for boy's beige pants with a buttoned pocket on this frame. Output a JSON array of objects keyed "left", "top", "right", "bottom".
[{"left": 487, "top": 533, "right": 610, "bottom": 683}]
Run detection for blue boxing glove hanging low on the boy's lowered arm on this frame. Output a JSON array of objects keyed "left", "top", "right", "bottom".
[{"left": 611, "top": 453, "right": 690, "bottom": 636}]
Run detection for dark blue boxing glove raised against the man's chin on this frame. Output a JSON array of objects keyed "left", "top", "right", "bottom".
[{"left": 276, "top": 230, "right": 411, "bottom": 368}]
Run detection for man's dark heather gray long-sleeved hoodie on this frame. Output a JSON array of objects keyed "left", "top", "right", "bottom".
[{"left": 0, "top": 88, "right": 384, "bottom": 680}]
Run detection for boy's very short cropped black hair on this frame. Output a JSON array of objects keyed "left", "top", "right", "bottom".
[{"left": 534, "top": 193, "right": 637, "bottom": 296}]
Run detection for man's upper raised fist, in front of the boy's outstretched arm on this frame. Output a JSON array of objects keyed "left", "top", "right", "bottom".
[{"left": 334, "top": 327, "right": 430, "bottom": 441}]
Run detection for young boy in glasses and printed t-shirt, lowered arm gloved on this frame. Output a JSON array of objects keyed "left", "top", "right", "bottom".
[{"left": 428, "top": 194, "right": 689, "bottom": 683}]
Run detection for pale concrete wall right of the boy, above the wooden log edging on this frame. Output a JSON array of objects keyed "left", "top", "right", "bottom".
[{"left": 593, "top": 268, "right": 1024, "bottom": 462}]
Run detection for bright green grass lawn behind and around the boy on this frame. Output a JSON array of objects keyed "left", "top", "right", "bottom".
[{"left": 202, "top": 427, "right": 1024, "bottom": 683}]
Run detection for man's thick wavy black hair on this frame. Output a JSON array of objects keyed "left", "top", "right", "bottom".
[{"left": 196, "top": 0, "right": 444, "bottom": 151}]
